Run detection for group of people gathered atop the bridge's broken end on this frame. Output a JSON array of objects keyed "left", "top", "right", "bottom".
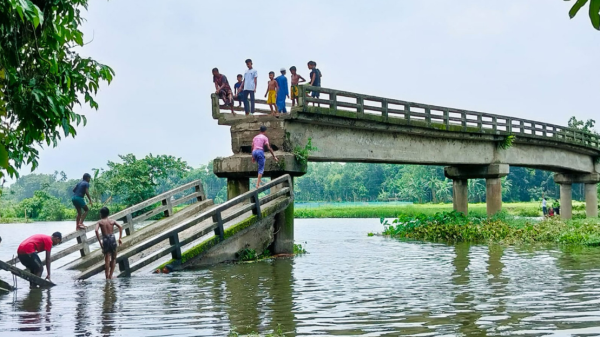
[{"left": 212, "top": 59, "right": 322, "bottom": 116}]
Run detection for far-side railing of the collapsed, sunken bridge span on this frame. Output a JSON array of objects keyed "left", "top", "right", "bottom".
[{"left": 7, "top": 180, "right": 206, "bottom": 265}]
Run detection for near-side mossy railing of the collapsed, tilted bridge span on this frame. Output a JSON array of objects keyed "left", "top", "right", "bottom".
[{"left": 78, "top": 175, "right": 294, "bottom": 280}]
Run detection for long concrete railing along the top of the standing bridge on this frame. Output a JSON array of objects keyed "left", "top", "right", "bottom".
[{"left": 299, "top": 85, "right": 600, "bottom": 150}]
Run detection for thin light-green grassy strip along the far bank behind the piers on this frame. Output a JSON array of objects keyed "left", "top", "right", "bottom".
[{"left": 294, "top": 202, "right": 585, "bottom": 219}]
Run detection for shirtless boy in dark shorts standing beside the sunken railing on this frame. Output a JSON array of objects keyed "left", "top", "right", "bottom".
[{"left": 96, "top": 207, "right": 123, "bottom": 280}]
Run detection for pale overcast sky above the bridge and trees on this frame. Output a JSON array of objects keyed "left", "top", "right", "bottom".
[{"left": 14, "top": 0, "right": 600, "bottom": 178}]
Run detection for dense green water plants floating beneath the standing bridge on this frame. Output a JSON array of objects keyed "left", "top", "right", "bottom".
[{"left": 381, "top": 211, "right": 600, "bottom": 246}]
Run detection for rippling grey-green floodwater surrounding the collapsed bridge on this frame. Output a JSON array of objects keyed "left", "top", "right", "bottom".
[{"left": 0, "top": 219, "right": 600, "bottom": 337}]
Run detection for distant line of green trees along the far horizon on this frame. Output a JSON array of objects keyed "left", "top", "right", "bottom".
[{"left": 0, "top": 154, "right": 596, "bottom": 220}]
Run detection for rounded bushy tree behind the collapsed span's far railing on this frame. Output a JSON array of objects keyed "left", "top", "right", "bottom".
[{"left": 102, "top": 154, "right": 190, "bottom": 206}]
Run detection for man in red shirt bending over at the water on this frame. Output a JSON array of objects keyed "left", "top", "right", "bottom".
[{"left": 17, "top": 232, "right": 62, "bottom": 281}]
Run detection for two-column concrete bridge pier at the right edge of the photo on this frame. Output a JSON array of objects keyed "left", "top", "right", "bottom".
[{"left": 554, "top": 173, "right": 600, "bottom": 219}]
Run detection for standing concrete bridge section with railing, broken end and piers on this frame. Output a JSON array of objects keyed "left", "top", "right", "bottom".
[{"left": 212, "top": 86, "right": 600, "bottom": 218}]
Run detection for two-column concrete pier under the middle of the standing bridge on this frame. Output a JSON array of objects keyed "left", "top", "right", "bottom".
[{"left": 444, "top": 164, "right": 509, "bottom": 216}]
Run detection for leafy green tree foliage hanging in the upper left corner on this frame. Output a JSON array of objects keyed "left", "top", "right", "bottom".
[{"left": 0, "top": 0, "right": 114, "bottom": 178}]
